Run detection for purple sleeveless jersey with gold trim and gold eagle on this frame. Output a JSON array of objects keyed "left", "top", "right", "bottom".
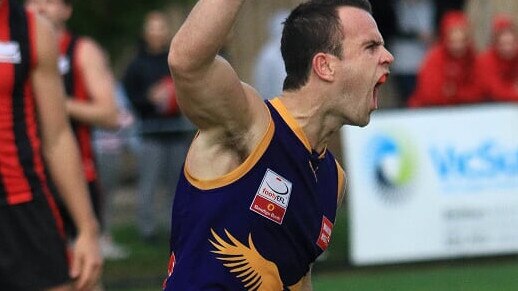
[{"left": 164, "top": 99, "right": 344, "bottom": 291}]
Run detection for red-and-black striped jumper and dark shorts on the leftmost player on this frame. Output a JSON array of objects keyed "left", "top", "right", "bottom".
[{"left": 0, "top": 0, "right": 69, "bottom": 290}]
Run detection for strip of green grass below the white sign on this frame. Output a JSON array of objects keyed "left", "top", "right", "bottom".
[{"left": 313, "top": 259, "right": 518, "bottom": 291}]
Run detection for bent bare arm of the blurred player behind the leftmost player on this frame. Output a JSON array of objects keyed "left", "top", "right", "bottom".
[{"left": 66, "top": 39, "right": 119, "bottom": 129}]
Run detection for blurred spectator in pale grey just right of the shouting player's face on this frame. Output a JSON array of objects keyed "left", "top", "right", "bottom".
[{"left": 388, "top": 0, "right": 434, "bottom": 106}]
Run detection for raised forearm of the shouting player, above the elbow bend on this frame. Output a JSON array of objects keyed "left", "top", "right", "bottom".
[{"left": 169, "top": 0, "right": 244, "bottom": 70}]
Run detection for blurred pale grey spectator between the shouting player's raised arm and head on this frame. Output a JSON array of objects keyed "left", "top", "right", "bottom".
[{"left": 254, "top": 10, "right": 289, "bottom": 99}]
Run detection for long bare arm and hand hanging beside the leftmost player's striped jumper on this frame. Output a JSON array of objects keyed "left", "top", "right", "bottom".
[{"left": 31, "top": 18, "right": 102, "bottom": 290}]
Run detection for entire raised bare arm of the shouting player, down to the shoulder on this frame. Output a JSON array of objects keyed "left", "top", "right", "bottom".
[{"left": 169, "top": 0, "right": 269, "bottom": 140}]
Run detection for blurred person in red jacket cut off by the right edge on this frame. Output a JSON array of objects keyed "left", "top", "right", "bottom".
[{"left": 477, "top": 14, "right": 518, "bottom": 102}]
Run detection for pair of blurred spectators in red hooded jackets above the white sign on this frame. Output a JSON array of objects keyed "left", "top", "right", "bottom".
[{"left": 408, "top": 12, "right": 518, "bottom": 107}]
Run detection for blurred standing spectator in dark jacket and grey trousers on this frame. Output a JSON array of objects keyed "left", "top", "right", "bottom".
[{"left": 123, "top": 11, "right": 194, "bottom": 242}]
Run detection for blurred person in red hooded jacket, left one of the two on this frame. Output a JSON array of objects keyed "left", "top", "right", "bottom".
[{"left": 408, "top": 11, "right": 482, "bottom": 107}]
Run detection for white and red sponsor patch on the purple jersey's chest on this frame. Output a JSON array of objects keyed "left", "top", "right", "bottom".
[{"left": 250, "top": 169, "right": 292, "bottom": 224}]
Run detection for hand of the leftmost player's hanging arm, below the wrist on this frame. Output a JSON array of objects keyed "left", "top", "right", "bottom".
[{"left": 70, "top": 232, "right": 103, "bottom": 290}]
